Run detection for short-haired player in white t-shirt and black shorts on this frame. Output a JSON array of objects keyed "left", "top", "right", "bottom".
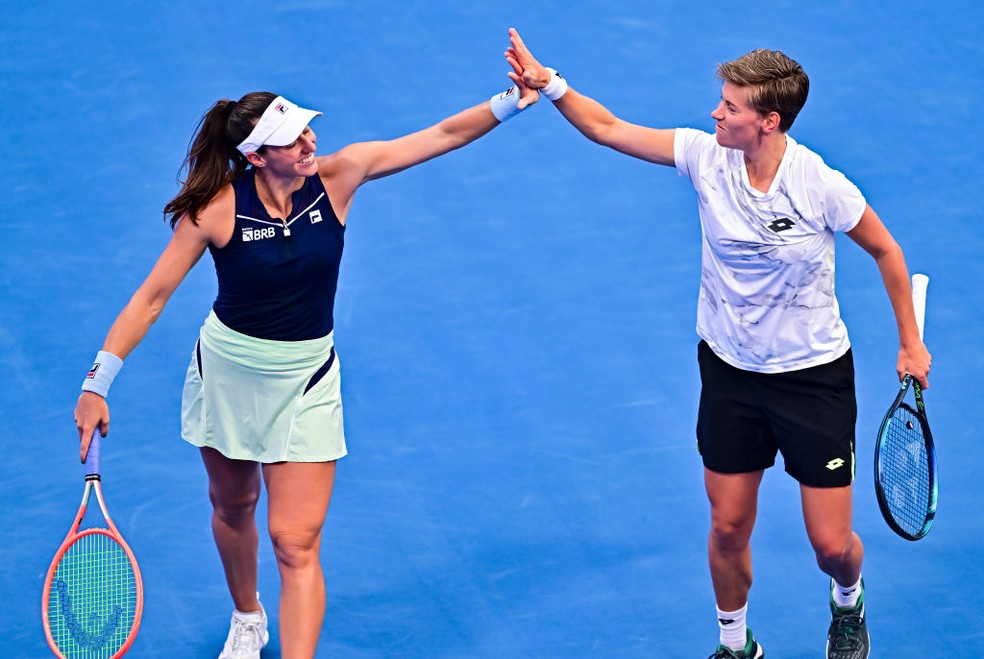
[{"left": 506, "top": 25, "right": 930, "bottom": 659}]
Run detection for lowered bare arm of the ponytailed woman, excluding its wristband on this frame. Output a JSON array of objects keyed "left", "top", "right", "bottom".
[{"left": 75, "top": 196, "right": 221, "bottom": 461}]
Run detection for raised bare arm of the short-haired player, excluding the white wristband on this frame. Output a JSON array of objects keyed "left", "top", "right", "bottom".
[{"left": 506, "top": 28, "right": 675, "bottom": 166}]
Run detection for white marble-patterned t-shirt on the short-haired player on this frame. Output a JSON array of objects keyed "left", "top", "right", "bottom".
[{"left": 674, "top": 128, "right": 866, "bottom": 373}]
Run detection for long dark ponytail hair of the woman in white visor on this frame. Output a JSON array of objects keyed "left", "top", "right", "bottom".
[{"left": 164, "top": 92, "right": 277, "bottom": 229}]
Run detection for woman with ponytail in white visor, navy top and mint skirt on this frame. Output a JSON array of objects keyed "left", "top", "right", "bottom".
[{"left": 75, "top": 71, "right": 539, "bottom": 659}]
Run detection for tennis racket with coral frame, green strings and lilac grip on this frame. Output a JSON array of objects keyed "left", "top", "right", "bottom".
[{"left": 41, "top": 428, "right": 143, "bottom": 659}]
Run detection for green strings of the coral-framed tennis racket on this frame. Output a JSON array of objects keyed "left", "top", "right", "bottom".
[{"left": 48, "top": 533, "right": 137, "bottom": 659}]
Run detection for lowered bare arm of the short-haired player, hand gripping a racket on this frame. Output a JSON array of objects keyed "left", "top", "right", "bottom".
[{"left": 847, "top": 206, "right": 933, "bottom": 389}]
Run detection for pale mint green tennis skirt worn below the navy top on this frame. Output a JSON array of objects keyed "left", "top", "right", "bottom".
[{"left": 181, "top": 313, "right": 347, "bottom": 463}]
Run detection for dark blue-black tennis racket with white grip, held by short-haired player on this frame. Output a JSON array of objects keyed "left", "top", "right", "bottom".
[{"left": 875, "top": 274, "right": 938, "bottom": 540}]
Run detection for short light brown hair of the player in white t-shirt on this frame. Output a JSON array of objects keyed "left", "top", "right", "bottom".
[{"left": 717, "top": 48, "right": 810, "bottom": 133}]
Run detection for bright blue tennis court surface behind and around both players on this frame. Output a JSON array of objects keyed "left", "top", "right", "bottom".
[{"left": 0, "top": 0, "right": 984, "bottom": 659}]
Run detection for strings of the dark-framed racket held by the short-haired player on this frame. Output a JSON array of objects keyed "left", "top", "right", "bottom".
[{"left": 879, "top": 404, "right": 932, "bottom": 536}]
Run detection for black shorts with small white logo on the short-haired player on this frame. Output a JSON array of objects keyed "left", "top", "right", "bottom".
[{"left": 697, "top": 341, "right": 858, "bottom": 487}]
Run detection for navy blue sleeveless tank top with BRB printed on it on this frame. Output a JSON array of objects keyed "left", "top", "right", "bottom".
[{"left": 209, "top": 168, "right": 345, "bottom": 341}]
